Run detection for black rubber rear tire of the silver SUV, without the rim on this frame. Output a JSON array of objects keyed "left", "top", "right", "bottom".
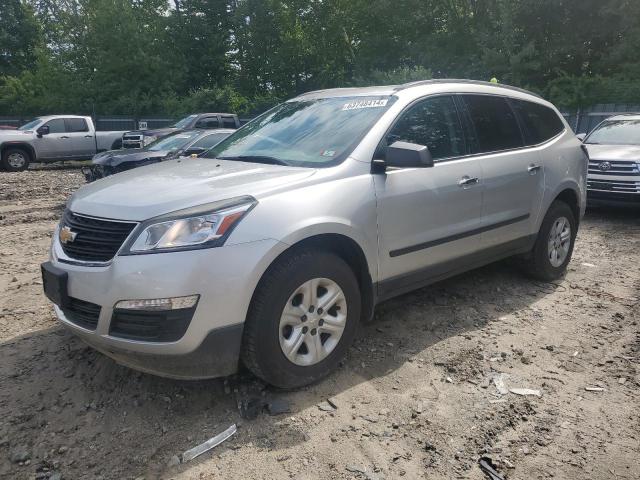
[{"left": 523, "top": 200, "right": 578, "bottom": 282}]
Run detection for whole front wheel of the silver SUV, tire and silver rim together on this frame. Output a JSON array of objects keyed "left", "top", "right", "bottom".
[{"left": 241, "top": 250, "right": 361, "bottom": 389}]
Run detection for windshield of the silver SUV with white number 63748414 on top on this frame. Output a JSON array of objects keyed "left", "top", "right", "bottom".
[{"left": 204, "top": 97, "right": 394, "bottom": 167}]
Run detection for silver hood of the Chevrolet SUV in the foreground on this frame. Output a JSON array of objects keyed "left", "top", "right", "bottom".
[{"left": 69, "top": 157, "right": 315, "bottom": 221}]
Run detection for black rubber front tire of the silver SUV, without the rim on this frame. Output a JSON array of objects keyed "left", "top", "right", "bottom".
[{"left": 241, "top": 250, "right": 361, "bottom": 389}]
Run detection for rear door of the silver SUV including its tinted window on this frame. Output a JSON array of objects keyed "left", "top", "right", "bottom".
[{"left": 459, "top": 94, "right": 544, "bottom": 247}]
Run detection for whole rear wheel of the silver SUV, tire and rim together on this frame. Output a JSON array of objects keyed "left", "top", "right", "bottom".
[{"left": 524, "top": 200, "right": 578, "bottom": 282}]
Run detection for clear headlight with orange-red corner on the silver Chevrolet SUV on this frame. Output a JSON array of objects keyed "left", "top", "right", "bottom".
[{"left": 125, "top": 197, "right": 257, "bottom": 255}]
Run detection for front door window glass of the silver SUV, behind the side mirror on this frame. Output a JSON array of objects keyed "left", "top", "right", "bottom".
[{"left": 386, "top": 97, "right": 466, "bottom": 160}]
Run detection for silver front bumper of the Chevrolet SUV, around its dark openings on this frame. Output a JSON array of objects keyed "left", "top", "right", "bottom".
[{"left": 51, "top": 239, "right": 286, "bottom": 379}]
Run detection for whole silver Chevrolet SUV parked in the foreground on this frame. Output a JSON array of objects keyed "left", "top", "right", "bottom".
[{"left": 42, "top": 80, "right": 587, "bottom": 388}]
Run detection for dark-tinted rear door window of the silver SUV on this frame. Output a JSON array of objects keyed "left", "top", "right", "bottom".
[{"left": 463, "top": 95, "right": 524, "bottom": 153}]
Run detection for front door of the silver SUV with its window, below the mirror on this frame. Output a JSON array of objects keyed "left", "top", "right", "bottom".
[{"left": 374, "top": 95, "right": 483, "bottom": 296}]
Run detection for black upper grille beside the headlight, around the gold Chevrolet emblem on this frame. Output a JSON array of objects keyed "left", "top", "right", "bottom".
[{"left": 60, "top": 210, "right": 136, "bottom": 262}]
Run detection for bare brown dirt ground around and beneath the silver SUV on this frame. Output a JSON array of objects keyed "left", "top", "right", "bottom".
[{"left": 0, "top": 168, "right": 640, "bottom": 480}]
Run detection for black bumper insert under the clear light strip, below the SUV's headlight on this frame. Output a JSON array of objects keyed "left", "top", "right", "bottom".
[{"left": 109, "top": 307, "right": 195, "bottom": 342}]
